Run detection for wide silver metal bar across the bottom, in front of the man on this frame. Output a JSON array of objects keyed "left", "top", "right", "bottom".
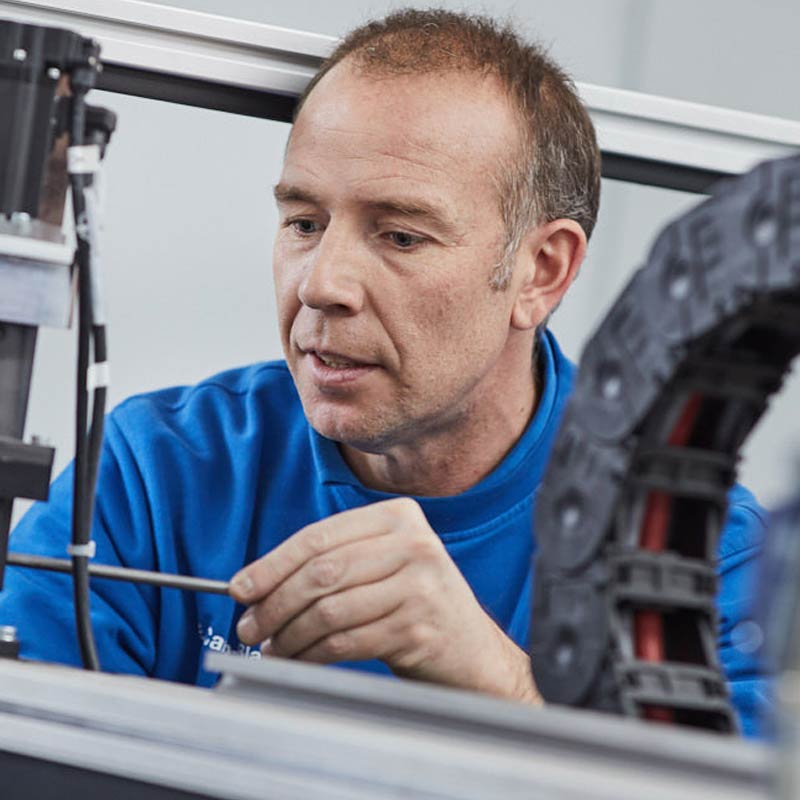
[{"left": 0, "top": 659, "right": 774, "bottom": 800}]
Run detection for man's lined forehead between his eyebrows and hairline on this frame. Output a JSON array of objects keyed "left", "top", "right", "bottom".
[{"left": 285, "top": 61, "right": 518, "bottom": 202}]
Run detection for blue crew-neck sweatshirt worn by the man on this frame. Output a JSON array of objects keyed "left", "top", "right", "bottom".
[{"left": 0, "top": 334, "right": 763, "bottom": 733}]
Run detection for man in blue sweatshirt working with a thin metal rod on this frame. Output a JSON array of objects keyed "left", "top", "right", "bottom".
[{"left": 0, "top": 11, "right": 760, "bottom": 729}]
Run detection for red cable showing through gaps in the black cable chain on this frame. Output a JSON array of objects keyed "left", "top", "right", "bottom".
[{"left": 634, "top": 395, "right": 702, "bottom": 722}]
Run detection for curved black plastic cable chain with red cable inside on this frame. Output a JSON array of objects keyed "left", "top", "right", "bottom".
[{"left": 531, "top": 152, "right": 800, "bottom": 732}]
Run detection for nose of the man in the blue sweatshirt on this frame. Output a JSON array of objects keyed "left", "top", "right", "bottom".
[{"left": 298, "top": 223, "right": 364, "bottom": 314}]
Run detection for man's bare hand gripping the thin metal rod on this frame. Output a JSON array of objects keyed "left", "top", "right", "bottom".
[{"left": 231, "top": 498, "right": 541, "bottom": 703}]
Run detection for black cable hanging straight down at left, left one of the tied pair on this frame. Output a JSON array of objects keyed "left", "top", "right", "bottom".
[{"left": 70, "top": 80, "right": 100, "bottom": 670}]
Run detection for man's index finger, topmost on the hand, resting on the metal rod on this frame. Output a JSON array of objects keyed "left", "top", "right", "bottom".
[{"left": 230, "top": 498, "right": 424, "bottom": 605}]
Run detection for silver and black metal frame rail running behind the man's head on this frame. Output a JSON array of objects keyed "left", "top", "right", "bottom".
[{"left": 0, "top": 0, "right": 800, "bottom": 192}]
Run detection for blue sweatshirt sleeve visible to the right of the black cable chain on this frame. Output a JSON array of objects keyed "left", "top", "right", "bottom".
[{"left": 718, "top": 486, "right": 770, "bottom": 737}]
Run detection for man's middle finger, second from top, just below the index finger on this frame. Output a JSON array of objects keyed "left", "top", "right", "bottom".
[{"left": 237, "top": 535, "right": 408, "bottom": 644}]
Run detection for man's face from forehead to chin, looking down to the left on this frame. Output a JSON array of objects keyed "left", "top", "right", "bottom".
[{"left": 274, "top": 62, "right": 516, "bottom": 452}]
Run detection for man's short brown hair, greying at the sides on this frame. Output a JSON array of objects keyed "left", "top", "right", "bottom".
[{"left": 295, "top": 9, "right": 600, "bottom": 288}]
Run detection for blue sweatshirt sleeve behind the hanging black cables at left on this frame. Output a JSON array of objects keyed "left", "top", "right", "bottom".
[{"left": 0, "top": 414, "right": 159, "bottom": 674}]
